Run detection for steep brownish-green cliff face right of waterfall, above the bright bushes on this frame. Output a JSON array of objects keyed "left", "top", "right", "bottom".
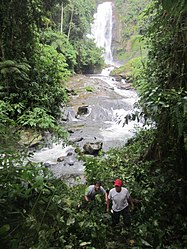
[{"left": 112, "top": 0, "right": 150, "bottom": 63}]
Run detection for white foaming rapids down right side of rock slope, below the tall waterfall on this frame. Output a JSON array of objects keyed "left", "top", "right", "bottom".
[{"left": 92, "top": 68, "right": 138, "bottom": 146}]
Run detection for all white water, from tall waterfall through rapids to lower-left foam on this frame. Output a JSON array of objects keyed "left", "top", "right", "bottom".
[{"left": 32, "top": 2, "right": 140, "bottom": 181}]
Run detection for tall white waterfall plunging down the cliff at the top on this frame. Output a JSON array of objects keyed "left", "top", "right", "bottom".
[{"left": 91, "top": 2, "right": 113, "bottom": 65}]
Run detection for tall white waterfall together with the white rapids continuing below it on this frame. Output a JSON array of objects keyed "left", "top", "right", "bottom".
[{"left": 88, "top": 2, "right": 140, "bottom": 147}]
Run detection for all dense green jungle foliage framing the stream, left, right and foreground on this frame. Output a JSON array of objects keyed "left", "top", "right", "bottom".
[{"left": 0, "top": 0, "right": 187, "bottom": 249}]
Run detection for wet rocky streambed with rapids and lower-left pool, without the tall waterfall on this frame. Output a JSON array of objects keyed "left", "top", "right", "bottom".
[{"left": 31, "top": 72, "right": 135, "bottom": 184}]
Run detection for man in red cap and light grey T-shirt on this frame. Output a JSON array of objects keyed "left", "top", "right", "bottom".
[{"left": 107, "top": 179, "right": 134, "bottom": 227}]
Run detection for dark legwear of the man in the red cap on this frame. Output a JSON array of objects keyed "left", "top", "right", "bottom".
[{"left": 112, "top": 206, "right": 131, "bottom": 227}]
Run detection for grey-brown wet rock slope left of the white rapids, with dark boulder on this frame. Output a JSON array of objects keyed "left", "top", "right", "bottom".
[{"left": 62, "top": 75, "right": 137, "bottom": 151}]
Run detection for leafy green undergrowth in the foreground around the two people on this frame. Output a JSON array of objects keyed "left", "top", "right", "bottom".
[{"left": 0, "top": 127, "right": 187, "bottom": 249}]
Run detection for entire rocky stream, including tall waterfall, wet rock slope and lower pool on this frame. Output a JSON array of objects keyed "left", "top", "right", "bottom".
[{"left": 32, "top": 1, "right": 140, "bottom": 184}]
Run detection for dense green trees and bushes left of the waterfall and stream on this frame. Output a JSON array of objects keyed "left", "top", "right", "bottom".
[{"left": 0, "top": 0, "right": 103, "bottom": 136}]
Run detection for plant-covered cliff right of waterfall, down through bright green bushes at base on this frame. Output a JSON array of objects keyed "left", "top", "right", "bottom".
[{"left": 112, "top": 0, "right": 151, "bottom": 81}]
